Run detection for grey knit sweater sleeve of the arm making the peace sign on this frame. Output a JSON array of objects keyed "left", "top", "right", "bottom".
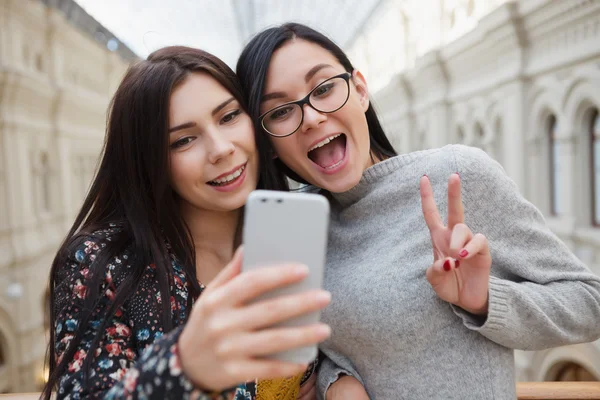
[{"left": 453, "top": 146, "right": 600, "bottom": 350}]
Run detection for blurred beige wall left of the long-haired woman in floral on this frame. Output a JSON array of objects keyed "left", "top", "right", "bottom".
[{"left": 0, "top": 0, "right": 127, "bottom": 393}]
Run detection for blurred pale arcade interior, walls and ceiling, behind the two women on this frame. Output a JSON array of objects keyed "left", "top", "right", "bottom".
[{"left": 0, "top": 0, "right": 600, "bottom": 393}]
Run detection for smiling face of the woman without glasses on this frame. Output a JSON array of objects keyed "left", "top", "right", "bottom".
[{"left": 169, "top": 72, "right": 258, "bottom": 211}]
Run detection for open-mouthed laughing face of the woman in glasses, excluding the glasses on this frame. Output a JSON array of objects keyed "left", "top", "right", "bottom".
[{"left": 260, "top": 39, "right": 373, "bottom": 193}]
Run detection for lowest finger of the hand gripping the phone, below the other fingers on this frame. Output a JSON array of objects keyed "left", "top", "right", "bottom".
[{"left": 225, "top": 359, "right": 307, "bottom": 382}]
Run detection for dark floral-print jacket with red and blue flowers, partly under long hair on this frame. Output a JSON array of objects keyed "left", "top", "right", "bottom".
[{"left": 54, "top": 226, "right": 256, "bottom": 400}]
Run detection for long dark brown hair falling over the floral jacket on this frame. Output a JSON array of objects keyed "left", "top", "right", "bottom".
[{"left": 42, "top": 46, "right": 245, "bottom": 399}]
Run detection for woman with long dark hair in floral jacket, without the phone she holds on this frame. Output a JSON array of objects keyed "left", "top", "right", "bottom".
[{"left": 43, "top": 47, "right": 336, "bottom": 400}]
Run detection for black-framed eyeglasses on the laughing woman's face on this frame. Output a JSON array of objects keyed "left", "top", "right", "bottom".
[{"left": 258, "top": 72, "right": 352, "bottom": 137}]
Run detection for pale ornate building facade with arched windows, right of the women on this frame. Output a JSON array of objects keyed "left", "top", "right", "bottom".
[{"left": 360, "top": 0, "right": 600, "bottom": 381}]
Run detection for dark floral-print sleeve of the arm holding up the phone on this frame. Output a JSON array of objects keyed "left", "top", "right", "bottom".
[{"left": 54, "top": 240, "right": 239, "bottom": 400}]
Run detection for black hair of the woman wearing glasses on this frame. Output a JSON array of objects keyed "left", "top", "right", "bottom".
[{"left": 236, "top": 23, "right": 396, "bottom": 189}]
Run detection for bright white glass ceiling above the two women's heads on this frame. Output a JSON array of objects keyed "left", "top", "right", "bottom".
[{"left": 76, "top": 0, "right": 385, "bottom": 66}]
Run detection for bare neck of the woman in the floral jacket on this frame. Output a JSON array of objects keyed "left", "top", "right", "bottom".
[{"left": 182, "top": 205, "right": 241, "bottom": 285}]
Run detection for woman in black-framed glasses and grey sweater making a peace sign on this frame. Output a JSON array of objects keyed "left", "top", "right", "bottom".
[{"left": 237, "top": 23, "right": 600, "bottom": 400}]
